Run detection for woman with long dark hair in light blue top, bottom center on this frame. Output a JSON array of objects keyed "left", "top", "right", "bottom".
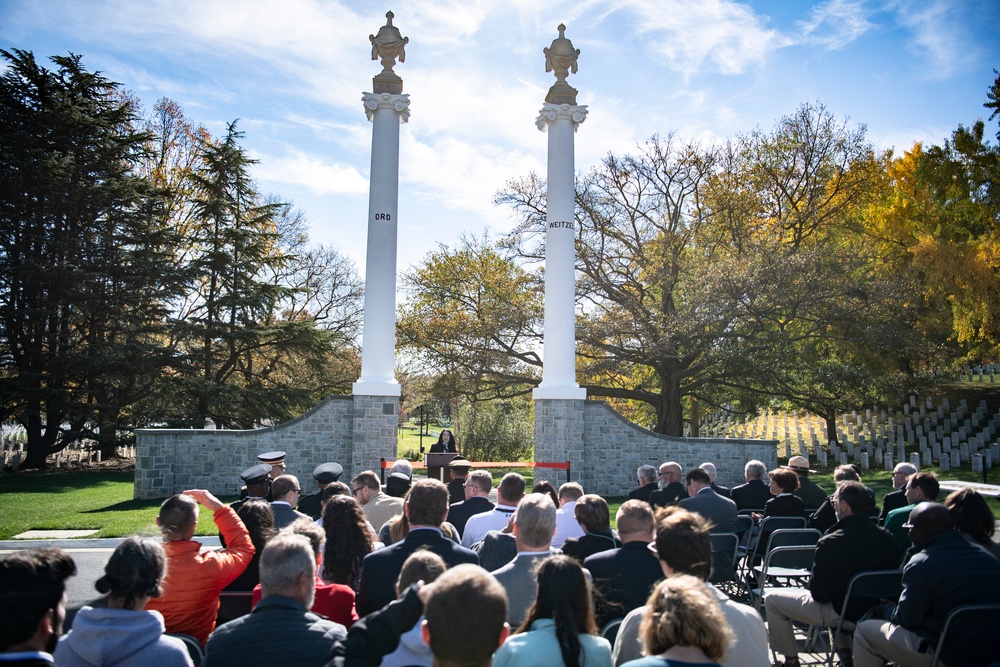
[{"left": 493, "top": 556, "right": 611, "bottom": 667}]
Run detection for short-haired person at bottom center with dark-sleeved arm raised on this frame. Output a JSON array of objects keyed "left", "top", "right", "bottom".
[{"left": 330, "top": 564, "right": 510, "bottom": 667}]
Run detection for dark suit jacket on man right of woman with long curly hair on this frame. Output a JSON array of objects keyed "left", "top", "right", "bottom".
[{"left": 355, "top": 529, "right": 479, "bottom": 616}]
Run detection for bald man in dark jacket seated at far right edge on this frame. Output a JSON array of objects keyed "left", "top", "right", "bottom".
[{"left": 854, "top": 502, "right": 1000, "bottom": 667}]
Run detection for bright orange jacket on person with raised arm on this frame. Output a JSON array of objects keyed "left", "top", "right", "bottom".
[{"left": 146, "top": 507, "right": 254, "bottom": 646}]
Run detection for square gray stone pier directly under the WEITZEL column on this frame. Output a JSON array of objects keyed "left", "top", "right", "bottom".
[{"left": 535, "top": 396, "right": 586, "bottom": 488}]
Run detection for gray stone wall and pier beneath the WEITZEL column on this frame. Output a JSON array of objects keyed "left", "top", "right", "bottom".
[{"left": 535, "top": 399, "right": 778, "bottom": 496}]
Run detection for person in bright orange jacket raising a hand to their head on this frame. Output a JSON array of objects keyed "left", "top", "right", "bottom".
[{"left": 146, "top": 489, "right": 254, "bottom": 646}]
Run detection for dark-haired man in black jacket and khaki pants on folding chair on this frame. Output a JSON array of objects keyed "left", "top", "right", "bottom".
[{"left": 764, "top": 481, "right": 899, "bottom": 667}]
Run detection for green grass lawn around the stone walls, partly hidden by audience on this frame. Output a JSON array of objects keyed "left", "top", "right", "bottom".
[{"left": 0, "top": 468, "right": 1000, "bottom": 539}]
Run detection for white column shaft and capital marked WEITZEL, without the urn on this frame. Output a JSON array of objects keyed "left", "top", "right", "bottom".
[{"left": 532, "top": 103, "right": 587, "bottom": 399}]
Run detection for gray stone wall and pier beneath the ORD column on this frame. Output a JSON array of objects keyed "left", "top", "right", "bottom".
[{"left": 134, "top": 396, "right": 399, "bottom": 499}]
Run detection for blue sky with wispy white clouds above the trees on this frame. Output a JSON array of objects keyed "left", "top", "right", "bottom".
[{"left": 0, "top": 0, "right": 1000, "bottom": 275}]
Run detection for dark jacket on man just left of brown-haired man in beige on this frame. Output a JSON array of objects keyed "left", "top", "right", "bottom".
[{"left": 583, "top": 541, "right": 663, "bottom": 626}]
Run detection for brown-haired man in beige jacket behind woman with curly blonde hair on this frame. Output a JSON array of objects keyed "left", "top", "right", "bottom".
[{"left": 614, "top": 507, "right": 771, "bottom": 667}]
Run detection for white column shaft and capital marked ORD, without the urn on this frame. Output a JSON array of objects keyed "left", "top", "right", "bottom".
[{"left": 353, "top": 93, "right": 410, "bottom": 396}]
